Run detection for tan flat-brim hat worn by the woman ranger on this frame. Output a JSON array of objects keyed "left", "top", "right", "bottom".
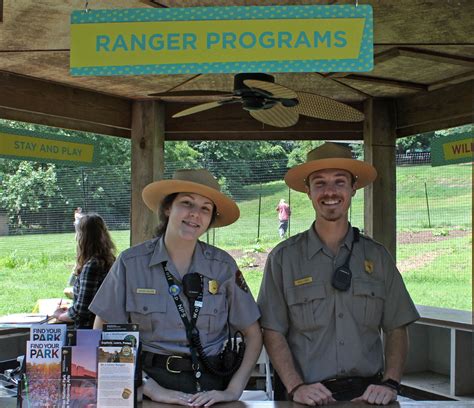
[{"left": 142, "top": 169, "right": 240, "bottom": 228}]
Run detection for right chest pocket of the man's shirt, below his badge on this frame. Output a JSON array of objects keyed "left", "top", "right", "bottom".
[{"left": 353, "top": 279, "right": 385, "bottom": 328}]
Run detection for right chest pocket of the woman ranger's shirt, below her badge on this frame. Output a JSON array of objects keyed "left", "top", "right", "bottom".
[{"left": 196, "top": 293, "right": 228, "bottom": 339}]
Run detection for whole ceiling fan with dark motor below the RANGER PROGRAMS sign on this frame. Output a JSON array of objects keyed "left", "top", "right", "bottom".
[{"left": 150, "top": 73, "right": 364, "bottom": 127}]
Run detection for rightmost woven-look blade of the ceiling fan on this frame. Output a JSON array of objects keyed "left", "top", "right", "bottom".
[{"left": 289, "top": 92, "right": 364, "bottom": 122}]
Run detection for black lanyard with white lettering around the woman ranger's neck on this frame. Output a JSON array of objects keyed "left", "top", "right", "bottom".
[{"left": 161, "top": 261, "right": 203, "bottom": 392}]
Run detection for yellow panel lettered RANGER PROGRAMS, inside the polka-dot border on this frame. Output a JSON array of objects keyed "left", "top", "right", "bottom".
[{"left": 71, "top": 18, "right": 364, "bottom": 67}]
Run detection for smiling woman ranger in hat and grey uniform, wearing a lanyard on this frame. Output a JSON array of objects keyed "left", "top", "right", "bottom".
[{"left": 90, "top": 169, "right": 262, "bottom": 406}]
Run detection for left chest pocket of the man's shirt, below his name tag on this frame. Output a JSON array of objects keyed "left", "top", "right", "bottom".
[{"left": 286, "top": 284, "right": 329, "bottom": 331}]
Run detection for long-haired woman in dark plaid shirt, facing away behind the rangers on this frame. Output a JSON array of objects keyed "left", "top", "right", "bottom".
[{"left": 53, "top": 213, "right": 115, "bottom": 329}]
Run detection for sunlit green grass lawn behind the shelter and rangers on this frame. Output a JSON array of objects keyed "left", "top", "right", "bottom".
[{"left": 0, "top": 165, "right": 472, "bottom": 315}]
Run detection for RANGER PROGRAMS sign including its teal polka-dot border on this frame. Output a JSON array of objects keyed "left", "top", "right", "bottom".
[{"left": 70, "top": 4, "right": 374, "bottom": 76}]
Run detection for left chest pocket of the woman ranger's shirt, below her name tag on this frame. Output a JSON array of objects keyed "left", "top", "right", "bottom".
[{"left": 125, "top": 293, "right": 166, "bottom": 333}]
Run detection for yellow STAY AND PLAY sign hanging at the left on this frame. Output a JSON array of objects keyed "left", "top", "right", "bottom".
[{"left": 0, "top": 131, "right": 94, "bottom": 164}]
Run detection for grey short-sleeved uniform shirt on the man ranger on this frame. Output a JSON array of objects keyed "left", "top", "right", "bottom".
[{"left": 258, "top": 224, "right": 419, "bottom": 383}]
